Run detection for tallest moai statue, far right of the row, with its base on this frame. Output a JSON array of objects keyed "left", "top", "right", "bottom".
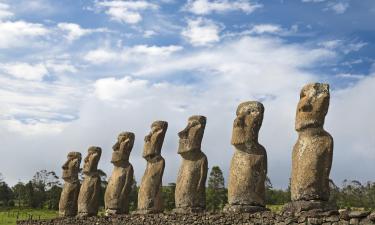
[{"left": 284, "top": 83, "right": 335, "bottom": 213}]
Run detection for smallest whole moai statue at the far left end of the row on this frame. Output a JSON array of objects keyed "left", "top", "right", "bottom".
[{"left": 59, "top": 152, "right": 82, "bottom": 217}]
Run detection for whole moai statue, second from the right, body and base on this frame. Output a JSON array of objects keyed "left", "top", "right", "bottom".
[{"left": 224, "top": 101, "right": 267, "bottom": 213}]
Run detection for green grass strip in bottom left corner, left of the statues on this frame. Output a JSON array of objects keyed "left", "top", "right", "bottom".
[{"left": 0, "top": 208, "right": 58, "bottom": 225}]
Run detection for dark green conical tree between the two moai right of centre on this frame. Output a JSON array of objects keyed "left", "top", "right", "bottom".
[{"left": 206, "top": 166, "right": 227, "bottom": 211}]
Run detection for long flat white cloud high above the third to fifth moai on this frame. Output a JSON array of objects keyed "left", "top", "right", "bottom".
[{"left": 83, "top": 45, "right": 183, "bottom": 64}]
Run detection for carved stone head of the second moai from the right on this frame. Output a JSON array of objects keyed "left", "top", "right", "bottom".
[{"left": 231, "top": 101, "right": 264, "bottom": 150}]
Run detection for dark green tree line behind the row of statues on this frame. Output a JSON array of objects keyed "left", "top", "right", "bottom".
[{"left": 0, "top": 166, "right": 375, "bottom": 211}]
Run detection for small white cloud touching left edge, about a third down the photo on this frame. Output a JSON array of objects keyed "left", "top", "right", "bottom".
[{"left": 0, "top": 62, "right": 48, "bottom": 81}]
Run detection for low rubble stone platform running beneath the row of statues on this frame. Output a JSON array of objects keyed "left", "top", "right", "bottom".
[{"left": 17, "top": 211, "right": 375, "bottom": 225}]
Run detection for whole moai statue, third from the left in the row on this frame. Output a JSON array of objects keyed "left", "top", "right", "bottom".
[{"left": 104, "top": 132, "right": 135, "bottom": 216}]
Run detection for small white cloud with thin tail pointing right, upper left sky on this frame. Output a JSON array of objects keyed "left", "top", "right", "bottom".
[{"left": 57, "top": 23, "right": 107, "bottom": 41}]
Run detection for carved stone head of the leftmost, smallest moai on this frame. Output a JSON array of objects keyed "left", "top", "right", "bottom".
[{"left": 62, "top": 152, "right": 82, "bottom": 182}]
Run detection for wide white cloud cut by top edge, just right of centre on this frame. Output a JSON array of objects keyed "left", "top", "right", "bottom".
[{"left": 184, "top": 0, "right": 262, "bottom": 15}]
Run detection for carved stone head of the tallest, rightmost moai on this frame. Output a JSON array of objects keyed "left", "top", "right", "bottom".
[{"left": 295, "top": 83, "right": 330, "bottom": 131}]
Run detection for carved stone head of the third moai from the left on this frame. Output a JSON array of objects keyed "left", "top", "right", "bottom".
[{"left": 111, "top": 132, "right": 135, "bottom": 165}]
